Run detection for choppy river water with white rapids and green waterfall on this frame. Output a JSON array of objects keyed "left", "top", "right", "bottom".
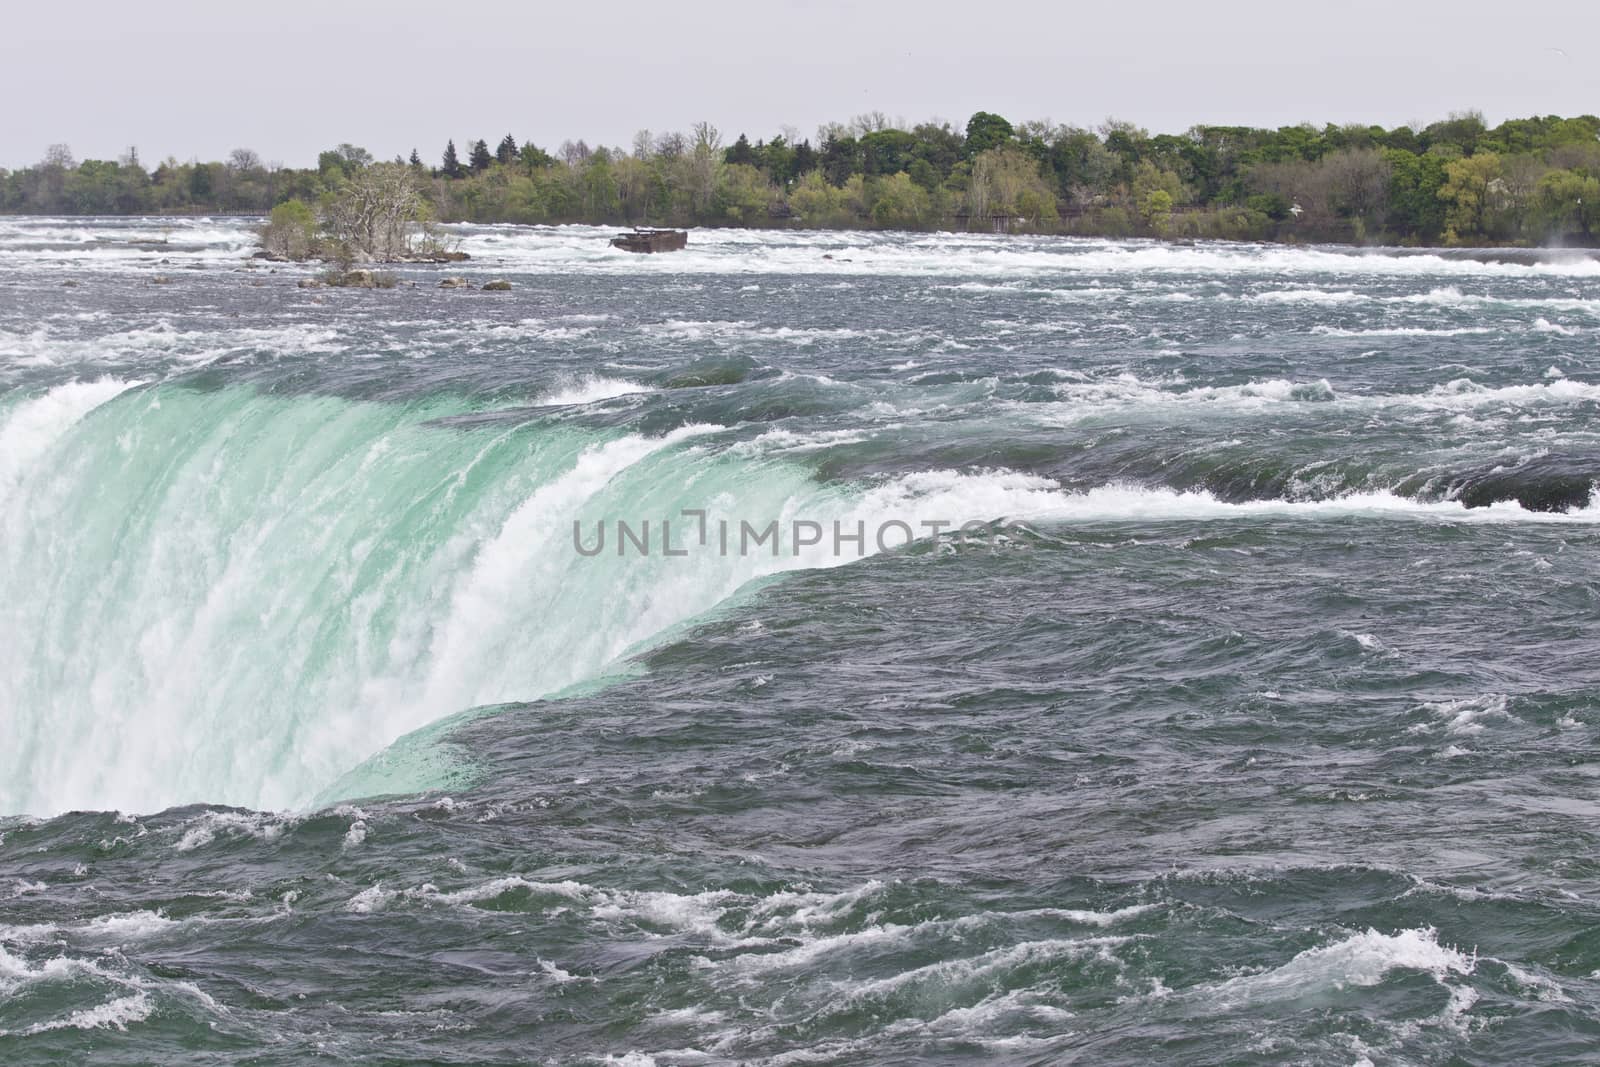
[{"left": 0, "top": 219, "right": 1600, "bottom": 1067}]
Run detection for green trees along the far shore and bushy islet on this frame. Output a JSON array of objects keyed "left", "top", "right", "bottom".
[{"left": 9, "top": 112, "right": 1600, "bottom": 252}]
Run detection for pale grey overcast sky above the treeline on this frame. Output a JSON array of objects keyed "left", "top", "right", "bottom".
[{"left": 0, "top": 0, "right": 1600, "bottom": 166}]
